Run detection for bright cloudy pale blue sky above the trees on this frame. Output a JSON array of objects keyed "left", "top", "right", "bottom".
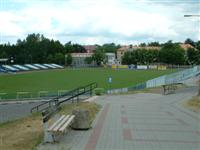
[{"left": 0, "top": 0, "right": 200, "bottom": 45}]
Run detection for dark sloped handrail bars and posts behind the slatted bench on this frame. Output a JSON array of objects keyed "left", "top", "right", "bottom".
[{"left": 31, "top": 82, "right": 97, "bottom": 112}]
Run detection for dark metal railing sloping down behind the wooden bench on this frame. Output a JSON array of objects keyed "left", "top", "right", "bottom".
[{"left": 31, "top": 82, "right": 97, "bottom": 113}]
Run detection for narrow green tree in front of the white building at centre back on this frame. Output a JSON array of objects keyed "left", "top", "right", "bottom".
[{"left": 92, "top": 47, "right": 105, "bottom": 66}]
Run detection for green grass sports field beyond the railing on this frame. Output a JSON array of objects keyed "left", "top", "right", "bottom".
[{"left": 0, "top": 69, "right": 175, "bottom": 99}]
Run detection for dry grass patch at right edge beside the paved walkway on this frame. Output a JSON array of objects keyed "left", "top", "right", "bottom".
[{"left": 184, "top": 96, "right": 200, "bottom": 112}]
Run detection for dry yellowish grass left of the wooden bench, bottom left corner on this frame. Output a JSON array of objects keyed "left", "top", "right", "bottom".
[{"left": 0, "top": 115, "right": 43, "bottom": 150}]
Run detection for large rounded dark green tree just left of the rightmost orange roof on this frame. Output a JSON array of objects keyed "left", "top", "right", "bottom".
[{"left": 159, "top": 42, "right": 185, "bottom": 65}]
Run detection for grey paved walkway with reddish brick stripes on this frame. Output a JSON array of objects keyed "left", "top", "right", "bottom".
[{"left": 38, "top": 88, "right": 200, "bottom": 150}]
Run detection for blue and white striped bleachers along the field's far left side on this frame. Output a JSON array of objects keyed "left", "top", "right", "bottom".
[{"left": 0, "top": 64, "right": 64, "bottom": 73}]
